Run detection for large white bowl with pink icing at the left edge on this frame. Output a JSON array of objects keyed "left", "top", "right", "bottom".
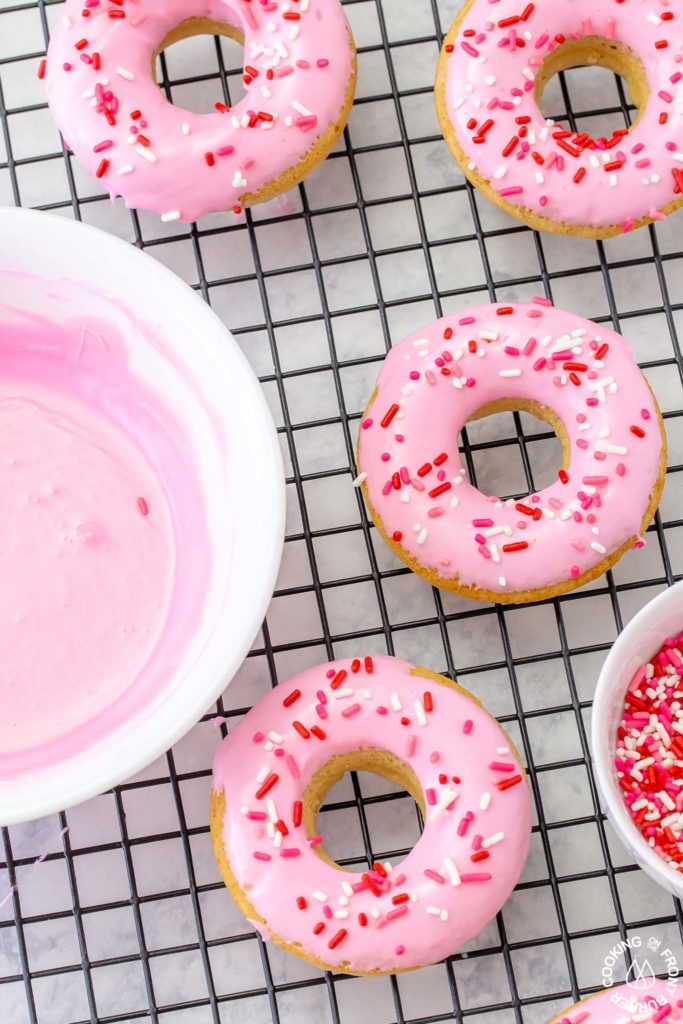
[{"left": 0, "top": 209, "right": 284, "bottom": 824}]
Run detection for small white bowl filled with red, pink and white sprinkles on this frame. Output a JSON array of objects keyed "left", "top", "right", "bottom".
[{"left": 592, "top": 583, "right": 683, "bottom": 899}]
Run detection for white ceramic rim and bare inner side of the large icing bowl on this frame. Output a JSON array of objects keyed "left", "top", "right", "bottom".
[{"left": 0, "top": 208, "right": 285, "bottom": 824}]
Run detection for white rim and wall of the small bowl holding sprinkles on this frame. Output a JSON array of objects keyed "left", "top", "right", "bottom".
[{"left": 591, "top": 583, "right": 683, "bottom": 899}]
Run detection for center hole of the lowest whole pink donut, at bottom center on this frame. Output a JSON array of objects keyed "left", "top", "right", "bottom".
[{"left": 303, "top": 749, "right": 424, "bottom": 872}]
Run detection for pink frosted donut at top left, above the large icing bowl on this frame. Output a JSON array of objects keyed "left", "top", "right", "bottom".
[{"left": 39, "top": 0, "right": 355, "bottom": 221}]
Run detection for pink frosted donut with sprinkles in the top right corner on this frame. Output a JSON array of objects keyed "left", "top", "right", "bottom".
[{"left": 436, "top": 0, "right": 683, "bottom": 239}]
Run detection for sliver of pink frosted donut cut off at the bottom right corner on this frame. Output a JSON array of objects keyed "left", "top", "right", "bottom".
[{"left": 550, "top": 974, "right": 683, "bottom": 1024}]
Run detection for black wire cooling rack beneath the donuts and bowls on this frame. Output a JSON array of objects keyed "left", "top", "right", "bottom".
[{"left": 0, "top": 0, "right": 683, "bottom": 1024}]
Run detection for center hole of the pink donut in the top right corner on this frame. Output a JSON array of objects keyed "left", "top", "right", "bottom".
[{"left": 535, "top": 36, "right": 649, "bottom": 139}]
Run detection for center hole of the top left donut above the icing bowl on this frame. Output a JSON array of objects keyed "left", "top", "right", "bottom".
[{"left": 152, "top": 17, "right": 246, "bottom": 114}]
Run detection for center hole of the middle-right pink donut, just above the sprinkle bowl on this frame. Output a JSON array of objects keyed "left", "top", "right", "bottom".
[{"left": 459, "top": 398, "right": 569, "bottom": 500}]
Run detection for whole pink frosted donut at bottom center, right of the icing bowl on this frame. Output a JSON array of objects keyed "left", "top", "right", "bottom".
[{"left": 211, "top": 657, "right": 531, "bottom": 974}]
